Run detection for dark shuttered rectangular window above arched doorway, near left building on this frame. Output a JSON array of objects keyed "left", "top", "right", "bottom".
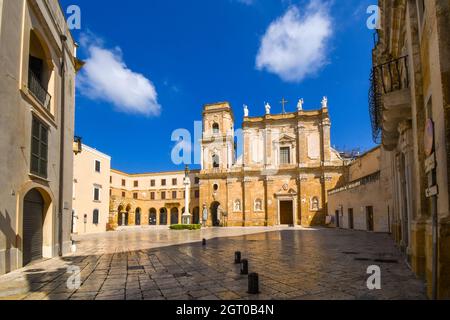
[{"left": 30, "top": 117, "right": 48, "bottom": 178}]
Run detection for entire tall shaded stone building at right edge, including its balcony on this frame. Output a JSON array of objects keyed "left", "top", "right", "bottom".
[{"left": 371, "top": 0, "right": 450, "bottom": 298}]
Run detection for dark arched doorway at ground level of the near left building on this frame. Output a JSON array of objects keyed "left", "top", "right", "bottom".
[{"left": 23, "top": 189, "right": 44, "bottom": 266}]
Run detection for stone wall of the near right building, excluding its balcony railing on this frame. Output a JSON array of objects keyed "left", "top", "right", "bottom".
[{"left": 374, "top": 0, "right": 450, "bottom": 298}]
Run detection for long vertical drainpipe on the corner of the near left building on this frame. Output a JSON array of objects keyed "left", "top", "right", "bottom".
[{"left": 58, "top": 34, "right": 67, "bottom": 256}]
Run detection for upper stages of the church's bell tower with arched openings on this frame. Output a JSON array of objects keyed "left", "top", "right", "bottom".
[{"left": 202, "top": 102, "right": 236, "bottom": 171}]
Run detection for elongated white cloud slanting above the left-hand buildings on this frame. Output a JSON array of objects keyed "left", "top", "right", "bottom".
[{"left": 78, "top": 35, "right": 161, "bottom": 116}]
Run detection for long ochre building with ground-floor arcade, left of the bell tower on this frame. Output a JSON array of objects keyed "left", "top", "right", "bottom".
[{"left": 108, "top": 170, "right": 200, "bottom": 230}]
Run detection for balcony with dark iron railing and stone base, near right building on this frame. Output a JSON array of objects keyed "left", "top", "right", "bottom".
[{"left": 369, "top": 56, "right": 411, "bottom": 150}]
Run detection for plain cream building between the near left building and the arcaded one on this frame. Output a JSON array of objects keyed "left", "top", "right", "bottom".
[{"left": 72, "top": 145, "right": 111, "bottom": 234}]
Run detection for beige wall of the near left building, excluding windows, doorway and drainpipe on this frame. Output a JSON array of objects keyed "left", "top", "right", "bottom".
[{"left": 0, "top": 0, "right": 75, "bottom": 274}]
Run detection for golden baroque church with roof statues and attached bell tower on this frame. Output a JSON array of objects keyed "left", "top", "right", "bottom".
[{"left": 199, "top": 98, "right": 345, "bottom": 226}]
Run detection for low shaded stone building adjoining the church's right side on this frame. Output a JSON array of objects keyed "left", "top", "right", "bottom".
[{"left": 328, "top": 147, "right": 393, "bottom": 233}]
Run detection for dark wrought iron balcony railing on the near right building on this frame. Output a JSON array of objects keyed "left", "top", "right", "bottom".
[{"left": 374, "top": 56, "right": 409, "bottom": 94}]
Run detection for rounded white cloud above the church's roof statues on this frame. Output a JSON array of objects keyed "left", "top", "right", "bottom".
[{"left": 256, "top": 0, "right": 332, "bottom": 82}]
